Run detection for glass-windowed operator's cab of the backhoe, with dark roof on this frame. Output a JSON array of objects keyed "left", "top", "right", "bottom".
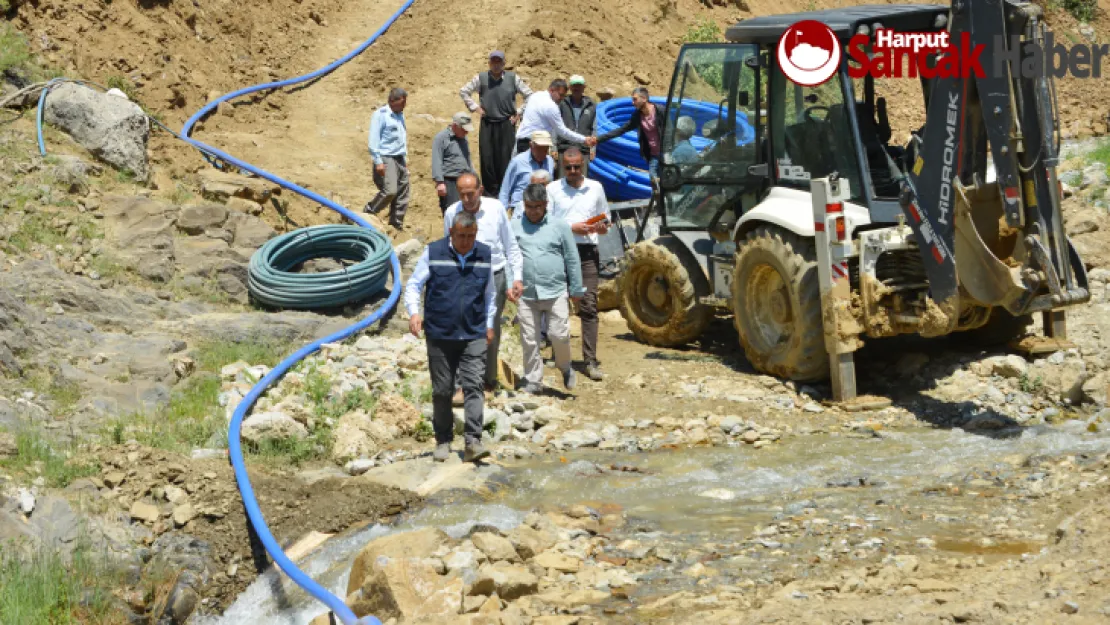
[{"left": 659, "top": 4, "right": 948, "bottom": 235}]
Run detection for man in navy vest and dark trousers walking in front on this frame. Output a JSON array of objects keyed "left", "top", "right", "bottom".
[{"left": 405, "top": 211, "right": 497, "bottom": 462}]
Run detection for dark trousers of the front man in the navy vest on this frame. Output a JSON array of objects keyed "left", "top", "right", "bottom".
[{"left": 427, "top": 337, "right": 486, "bottom": 445}]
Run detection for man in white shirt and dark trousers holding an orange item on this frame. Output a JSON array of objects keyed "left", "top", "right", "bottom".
[{"left": 547, "top": 148, "right": 609, "bottom": 382}]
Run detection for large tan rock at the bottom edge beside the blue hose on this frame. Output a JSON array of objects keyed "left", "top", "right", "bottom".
[{"left": 347, "top": 558, "right": 464, "bottom": 623}]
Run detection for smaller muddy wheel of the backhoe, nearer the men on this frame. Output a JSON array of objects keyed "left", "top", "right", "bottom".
[{"left": 618, "top": 236, "right": 713, "bottom": 347}]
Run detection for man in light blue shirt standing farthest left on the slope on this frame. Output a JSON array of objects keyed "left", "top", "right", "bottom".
[{"left": 364, "top": 87, "right": 408, "bottom": 230}]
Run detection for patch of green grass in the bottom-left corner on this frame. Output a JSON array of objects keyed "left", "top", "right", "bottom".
[{"left": 0, "top": 542, "right": 128, "bottom": 625}]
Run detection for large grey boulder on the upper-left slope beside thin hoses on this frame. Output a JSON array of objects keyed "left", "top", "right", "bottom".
[{"left": 46, "top": 82, "right": 150, "bottom": 182}]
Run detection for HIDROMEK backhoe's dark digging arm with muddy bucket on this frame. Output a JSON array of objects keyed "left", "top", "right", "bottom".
[{"left": 900, "top": 0, "right": 1090, "bottom": 334}]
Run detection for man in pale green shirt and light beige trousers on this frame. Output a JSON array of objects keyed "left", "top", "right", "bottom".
[{"left": 513, "top": 183, "right": 586, "bottom": 394}]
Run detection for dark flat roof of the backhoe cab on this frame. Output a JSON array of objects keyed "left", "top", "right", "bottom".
[{"left": 725, "top": 4, "right": 949, "bottom": 43}]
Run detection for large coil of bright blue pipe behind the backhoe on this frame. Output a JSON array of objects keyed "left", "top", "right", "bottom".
[{"left": 588, "top": 98, "right": 755, "bottom": 201}]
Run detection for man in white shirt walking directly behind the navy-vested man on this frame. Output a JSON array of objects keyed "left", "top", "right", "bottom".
[{"left": 443, "top": 173, "right": 524, "bottom": 391}]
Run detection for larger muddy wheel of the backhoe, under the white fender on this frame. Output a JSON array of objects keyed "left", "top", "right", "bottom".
[{"left": 733, "top": 225, "right": 829, "bottom": 382}]
